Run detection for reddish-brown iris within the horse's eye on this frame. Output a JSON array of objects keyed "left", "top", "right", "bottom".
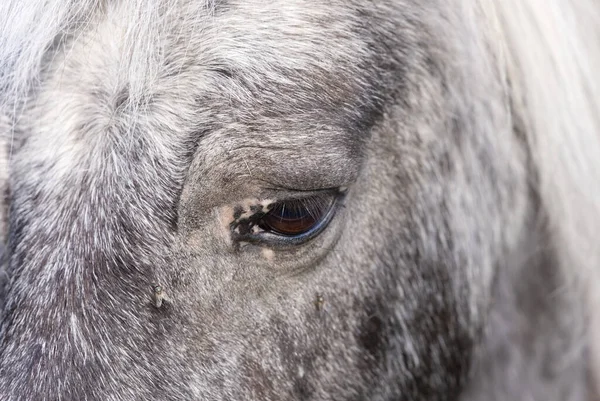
[{"left": 261, "top": 202, "right": 323, "bottom": 235}]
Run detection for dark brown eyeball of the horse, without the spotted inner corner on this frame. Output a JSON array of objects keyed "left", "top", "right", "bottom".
[{"left": 259, "top": 196, "right": 333, "bottom": 237}]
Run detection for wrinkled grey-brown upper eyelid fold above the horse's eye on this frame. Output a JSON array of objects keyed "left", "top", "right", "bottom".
[{"left": 190, "top": 133, "right": 361, "bottom": 196}]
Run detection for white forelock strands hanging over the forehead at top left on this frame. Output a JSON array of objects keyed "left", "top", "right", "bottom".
[{"left": 0, "top": 0, "right": 216, "bottom": 114}]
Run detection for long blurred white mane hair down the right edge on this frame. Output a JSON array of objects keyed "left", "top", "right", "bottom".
[{"left": 494, "top": 0, "right": 600, "bottom": 379}]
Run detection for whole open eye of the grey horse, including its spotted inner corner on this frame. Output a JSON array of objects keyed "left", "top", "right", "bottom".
[{"left": 231, "top": 191, "right": 340, "bottom": 245}]
